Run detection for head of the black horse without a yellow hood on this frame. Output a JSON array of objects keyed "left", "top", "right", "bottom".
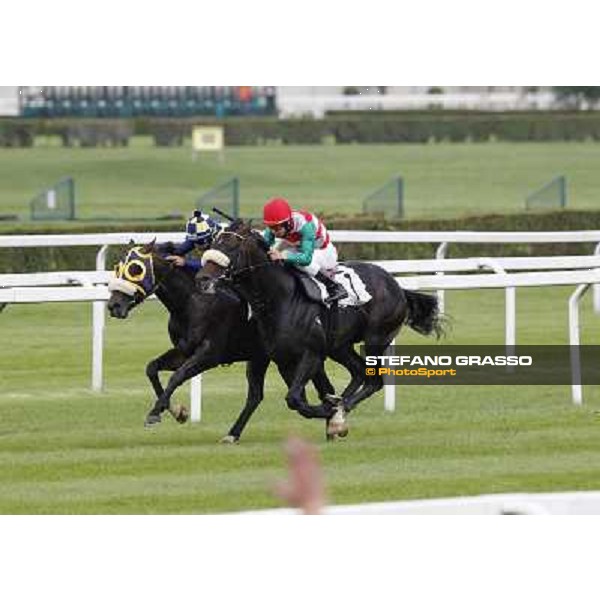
[{"left": 196, "top": 219, "right": 269, "bottom": 293}]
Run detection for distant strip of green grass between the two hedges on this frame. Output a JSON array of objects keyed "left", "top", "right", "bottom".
[{"left": 0, "top": 138, "right": 600, "bottom": 219}]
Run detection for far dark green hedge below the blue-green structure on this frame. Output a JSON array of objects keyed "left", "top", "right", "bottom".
[{"left": 8, "top": 110, "right": 600, "bottom": 146}]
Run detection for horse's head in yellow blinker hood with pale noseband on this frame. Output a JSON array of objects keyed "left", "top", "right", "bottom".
[{"left": 108, "top": 241, "right": 166, "bottom": 319}]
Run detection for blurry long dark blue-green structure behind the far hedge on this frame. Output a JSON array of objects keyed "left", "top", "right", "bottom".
[{"left": 19, "top": 86, "right": 276, "bottom": 118}]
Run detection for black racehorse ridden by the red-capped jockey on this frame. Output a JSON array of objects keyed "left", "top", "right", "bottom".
[{"left": 197, "top": 220, "right": 442, "bottom": 433}]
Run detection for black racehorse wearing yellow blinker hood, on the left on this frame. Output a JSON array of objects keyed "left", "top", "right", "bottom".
[{"left": 108, "top": 243, "right": 336, "bottom": 442}]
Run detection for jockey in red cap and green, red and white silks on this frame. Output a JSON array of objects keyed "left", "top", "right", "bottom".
[{"left": 263, "top": 198, "right": 348, "bottom": 302}]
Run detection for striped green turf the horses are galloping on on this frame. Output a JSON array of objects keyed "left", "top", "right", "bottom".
[{"left": 0, "top": 288, "right": 600, "bottom": 514}]
